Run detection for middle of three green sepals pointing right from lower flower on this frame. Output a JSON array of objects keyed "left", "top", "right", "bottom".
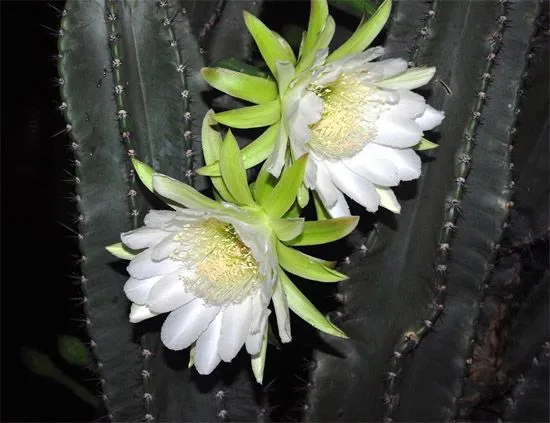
[{"left": 276, "top": 241, "right": 348, "bottom": 282}]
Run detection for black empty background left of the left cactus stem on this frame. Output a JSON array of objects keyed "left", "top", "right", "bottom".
[{"left": 0, "top": 1, "right": 97, "bottom": 421}]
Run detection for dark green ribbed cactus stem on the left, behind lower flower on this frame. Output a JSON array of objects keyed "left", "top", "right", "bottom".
[{"left": 58, "top": 0, "right": 261, "bottom": 421}]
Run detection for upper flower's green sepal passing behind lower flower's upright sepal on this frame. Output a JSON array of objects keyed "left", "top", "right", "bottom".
[{"left": 197, "top": 121, "right": 281, "bottom": 177}]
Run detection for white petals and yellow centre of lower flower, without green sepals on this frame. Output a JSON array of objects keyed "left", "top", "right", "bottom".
[{"left": 121, "top": 210, "right": 276, "bottom": 374}]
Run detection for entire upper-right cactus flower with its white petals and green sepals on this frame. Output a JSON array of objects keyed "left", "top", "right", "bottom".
[{"left": 199, "top": 0, "right": 444, "bottom": 217}]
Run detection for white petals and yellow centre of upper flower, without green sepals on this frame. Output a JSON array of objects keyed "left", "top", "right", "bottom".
[{"left": 283, "top": 47, "right": 444, "bottom": 217}]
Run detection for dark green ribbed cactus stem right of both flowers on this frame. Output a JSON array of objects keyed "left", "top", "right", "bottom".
[{"left": 307, "top": 1, "right": 538, "bottom": 421}]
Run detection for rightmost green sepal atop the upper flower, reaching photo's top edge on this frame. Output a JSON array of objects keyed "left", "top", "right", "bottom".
[{"left": 326, "top": 0, "right": 392, "bottom": 63}]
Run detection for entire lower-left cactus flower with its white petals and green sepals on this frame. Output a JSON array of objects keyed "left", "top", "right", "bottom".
[{"left": 107, "top": 112, "right": 358, "bottom": 383}]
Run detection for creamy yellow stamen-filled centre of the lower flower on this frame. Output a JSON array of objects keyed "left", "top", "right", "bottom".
[{"left": 170, "top": 218, "right": 263, "bottom": 305}]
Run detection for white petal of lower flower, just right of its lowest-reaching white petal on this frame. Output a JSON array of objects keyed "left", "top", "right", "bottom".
[{"left": 218, "top": 297, "right": 259, "bottom": 362}]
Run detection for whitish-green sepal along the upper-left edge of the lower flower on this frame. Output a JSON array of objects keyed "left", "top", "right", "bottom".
[{"left": 153, "top": 173, "right": 225, "bottom": 210}]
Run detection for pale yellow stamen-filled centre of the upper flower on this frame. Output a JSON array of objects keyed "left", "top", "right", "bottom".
[{"left": 309, "top": 74, "right": 383, "bottom": 158}]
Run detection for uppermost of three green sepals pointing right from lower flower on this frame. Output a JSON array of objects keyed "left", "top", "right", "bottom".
[{"left": 285, "top": 216, "right": 359, "bottom": 247}]
